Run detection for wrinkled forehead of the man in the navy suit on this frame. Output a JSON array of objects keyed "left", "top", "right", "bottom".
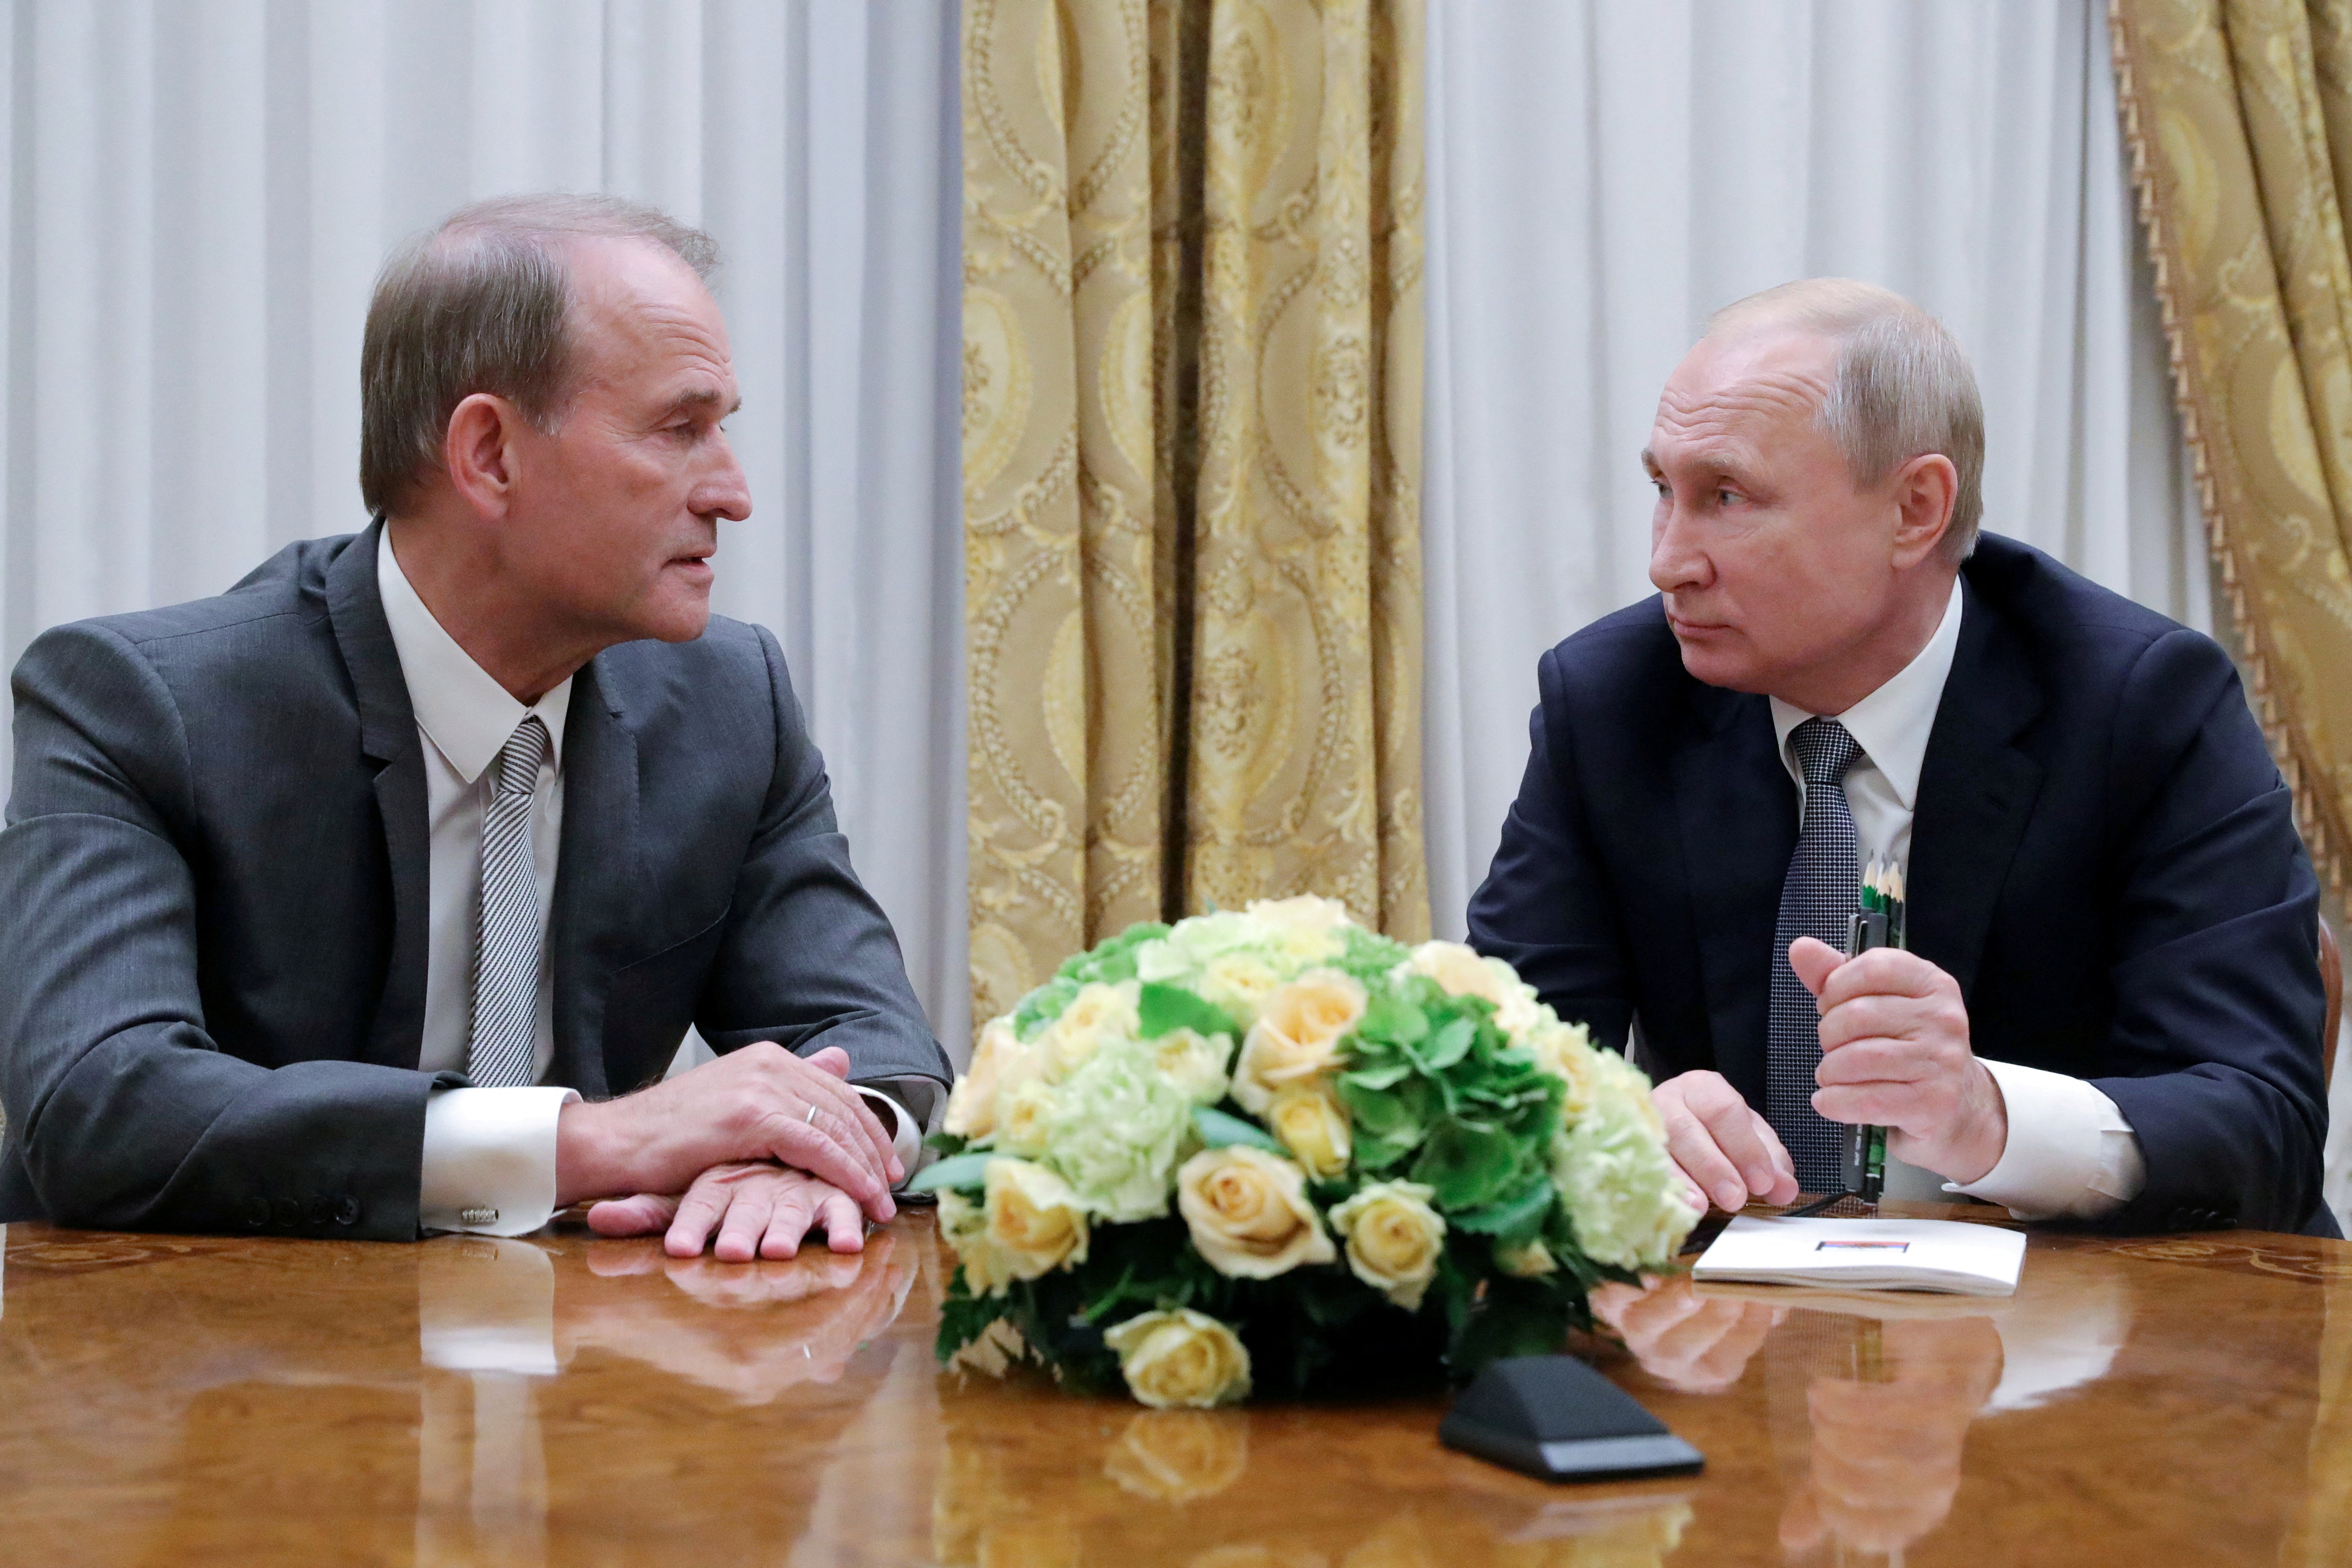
[{"left": 1651, "top": 327, "right": 1837, "bottom": 461}]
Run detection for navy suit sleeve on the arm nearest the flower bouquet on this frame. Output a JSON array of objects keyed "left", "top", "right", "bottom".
[{"left": 1470, "top": 649, "right": 1632, "bottom": 1051}]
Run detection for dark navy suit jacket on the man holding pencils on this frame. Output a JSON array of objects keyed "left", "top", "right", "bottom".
[{"left": 1470, "top": 533, "right": 2336, "bottom": 1236}]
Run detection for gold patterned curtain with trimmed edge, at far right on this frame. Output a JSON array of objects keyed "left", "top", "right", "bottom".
[{"left": 2107, "top": 0, "right": 2352, "bottom": 891}]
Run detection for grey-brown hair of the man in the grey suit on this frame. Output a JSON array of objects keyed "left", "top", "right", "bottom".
[{"left": 360, "top": 193, "right": 720, "bottom": 512}]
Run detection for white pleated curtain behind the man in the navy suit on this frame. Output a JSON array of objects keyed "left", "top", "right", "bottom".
[{"left": 1423, "top": 0, "right": 2211, "bottom": 935}]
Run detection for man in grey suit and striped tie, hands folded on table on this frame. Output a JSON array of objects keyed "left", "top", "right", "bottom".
[{"left": 0, "top": 197, "right": 948, "bottom": 1258}]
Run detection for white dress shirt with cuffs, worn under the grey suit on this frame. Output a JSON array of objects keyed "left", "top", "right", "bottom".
[{"left": 376, "top": 531, "right": 922, "bottom": 1236}]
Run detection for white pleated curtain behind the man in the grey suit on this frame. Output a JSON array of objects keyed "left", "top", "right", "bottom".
[{"left": 0, "top": 0, "right": 967, "bottom": 1053}]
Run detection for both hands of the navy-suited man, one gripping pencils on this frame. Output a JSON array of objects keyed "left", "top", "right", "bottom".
[{"left": 1651, "top": 935, "right": 2009, "bottom": 1211}]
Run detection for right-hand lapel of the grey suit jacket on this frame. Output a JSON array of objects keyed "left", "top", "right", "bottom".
[{"left": 548, "top": 660, "right": 638, "bottom": 1100}]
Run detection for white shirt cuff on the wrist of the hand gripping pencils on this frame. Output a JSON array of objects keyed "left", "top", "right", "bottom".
[{"left": 1943, "top": 1058, "right": 2147, "bottom": 1220}]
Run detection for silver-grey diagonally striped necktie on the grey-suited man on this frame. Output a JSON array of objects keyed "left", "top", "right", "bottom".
[{"left": 466, "top": 715, "right": 548, "bottom": 1088}]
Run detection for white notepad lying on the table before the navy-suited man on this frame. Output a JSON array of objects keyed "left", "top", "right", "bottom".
[{"left": 1691, "top": 1215, "right": 2025, "bottom": 1295}]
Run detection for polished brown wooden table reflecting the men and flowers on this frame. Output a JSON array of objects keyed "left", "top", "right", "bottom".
[{"left": 0, "top": 1206, "right": 2352, "bottom": 1568}]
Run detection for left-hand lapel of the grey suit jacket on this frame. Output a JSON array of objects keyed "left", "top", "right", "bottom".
[{"left": 327, "top": 522, "right": 430, "bottom": 1067}]
